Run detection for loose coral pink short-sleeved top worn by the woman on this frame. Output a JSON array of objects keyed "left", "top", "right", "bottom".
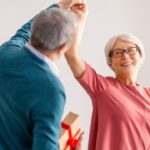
[{"left": 78, "top": 64, "right": 150, "bottom": 150}]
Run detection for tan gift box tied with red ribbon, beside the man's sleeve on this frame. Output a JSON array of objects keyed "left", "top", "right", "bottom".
[{"left": 59, "top": 112, "right": 81, "bottom": 150}]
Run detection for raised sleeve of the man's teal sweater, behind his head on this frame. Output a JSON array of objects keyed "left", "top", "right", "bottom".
[{"left": 3, "top": 4, "right": 59, "bottom": 48}]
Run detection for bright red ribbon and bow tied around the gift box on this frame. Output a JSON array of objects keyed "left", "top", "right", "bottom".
[{"left": 61, "top": 122, "right": 80, "bottom": 150}]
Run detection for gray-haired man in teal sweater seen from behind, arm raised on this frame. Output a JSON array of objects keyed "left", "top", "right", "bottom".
[{"left": 0, "top": 0, "right": 85, "bottom": 150}]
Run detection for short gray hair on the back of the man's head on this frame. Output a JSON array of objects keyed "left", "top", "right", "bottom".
[{"left": 31, "top": 8, "right": 77, "bottom": 50}]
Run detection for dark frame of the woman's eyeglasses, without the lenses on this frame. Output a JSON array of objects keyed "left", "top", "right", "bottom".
[{"left": 109, "top": 46, "right": 139, "bottom": 58}]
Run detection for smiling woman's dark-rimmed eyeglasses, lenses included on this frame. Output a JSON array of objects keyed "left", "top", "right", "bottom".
[{"left": 109, "top": 47, "right": 138, "bottom": 57}]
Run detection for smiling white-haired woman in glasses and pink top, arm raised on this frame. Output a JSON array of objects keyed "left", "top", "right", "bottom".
[{"left": 65, "top": 1, "right": 150, "bottom": 150}]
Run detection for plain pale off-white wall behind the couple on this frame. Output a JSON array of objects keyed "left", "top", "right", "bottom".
[{"left": 0, "top": 0, "right": 150, "bottom": 150}]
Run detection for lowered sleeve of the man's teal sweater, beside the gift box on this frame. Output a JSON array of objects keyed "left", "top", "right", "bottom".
[{"left": 32, "top": 82, "right": 65, "bottom": 150}]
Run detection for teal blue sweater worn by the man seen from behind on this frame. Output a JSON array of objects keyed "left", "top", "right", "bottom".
[{"left": 0, "top": 5, "right": 65, "bottom": 150}]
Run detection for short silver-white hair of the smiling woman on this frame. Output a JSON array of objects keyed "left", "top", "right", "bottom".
[{"left": 105, "top": 33, "right": 145, "bottom": 65}]
